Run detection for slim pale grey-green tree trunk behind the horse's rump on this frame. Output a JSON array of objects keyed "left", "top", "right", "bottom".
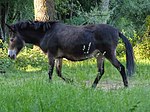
[{"left": 101, "top": 0, "right": 110, "bottom": 24}]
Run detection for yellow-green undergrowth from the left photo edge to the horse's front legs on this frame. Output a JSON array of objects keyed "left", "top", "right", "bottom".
[{"left": 0, "top": 47, "right": 48, "bottom": 72}]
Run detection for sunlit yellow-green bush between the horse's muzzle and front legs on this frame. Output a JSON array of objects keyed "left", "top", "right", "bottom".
[{"left": 14, "top": 47, "right": 48, "bottom": 70}]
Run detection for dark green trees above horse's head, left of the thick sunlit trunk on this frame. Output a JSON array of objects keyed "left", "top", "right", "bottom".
[{"left": 0, "top": 0, "right": 33, "bottom": 46}]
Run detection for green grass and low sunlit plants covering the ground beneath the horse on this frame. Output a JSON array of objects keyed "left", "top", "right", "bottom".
[{"left": 0, "top": 49, "right": 150, "bottom": 112}]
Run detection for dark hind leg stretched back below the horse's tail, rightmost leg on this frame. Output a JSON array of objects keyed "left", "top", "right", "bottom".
[{"left": 105, "top": 51, "right": 128, "bottom": 87}]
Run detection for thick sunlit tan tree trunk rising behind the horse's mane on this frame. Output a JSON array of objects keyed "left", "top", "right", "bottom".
[{"left": 34, "top": 0, "right": 55, "bottom": 21}]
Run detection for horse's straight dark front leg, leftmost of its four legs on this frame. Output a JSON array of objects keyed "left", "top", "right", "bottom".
[{"left": 48, "top": 53, "right": 55, "bottom": 80}]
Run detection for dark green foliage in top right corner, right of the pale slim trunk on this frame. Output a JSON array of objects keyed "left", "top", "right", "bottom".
[{"left": 112, "top": 0, "right": 150, "bottom": 27}]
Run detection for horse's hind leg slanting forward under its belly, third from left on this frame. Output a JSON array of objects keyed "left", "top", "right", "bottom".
[{"left": 92, "top": 54, "right": 104, "bottom": 88}]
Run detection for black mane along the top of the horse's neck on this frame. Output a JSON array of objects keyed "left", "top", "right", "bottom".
[{"left": 11, "top": 20, "right": 58, "bottom": 32}]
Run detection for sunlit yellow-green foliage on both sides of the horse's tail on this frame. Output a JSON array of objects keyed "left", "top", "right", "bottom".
[{"left": 117, "top": 28, "right": 150, "bottom": 59}]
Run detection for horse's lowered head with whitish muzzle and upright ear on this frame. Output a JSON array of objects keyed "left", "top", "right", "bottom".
[{"left": 6, "top": 24, "right": 25, "bottom": 59}]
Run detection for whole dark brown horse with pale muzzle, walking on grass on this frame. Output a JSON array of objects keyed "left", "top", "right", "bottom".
[{"left": 6, "top": 21, "right": 134, "bottom": 87}]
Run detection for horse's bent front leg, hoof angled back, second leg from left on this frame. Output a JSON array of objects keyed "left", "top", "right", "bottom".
[{"left": 55, "top": 58, "right": 71, "bottom": 82}]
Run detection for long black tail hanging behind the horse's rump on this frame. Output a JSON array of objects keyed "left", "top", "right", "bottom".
[{"left": 119, "top": 32, "right": 135, "bottom": 76}]
